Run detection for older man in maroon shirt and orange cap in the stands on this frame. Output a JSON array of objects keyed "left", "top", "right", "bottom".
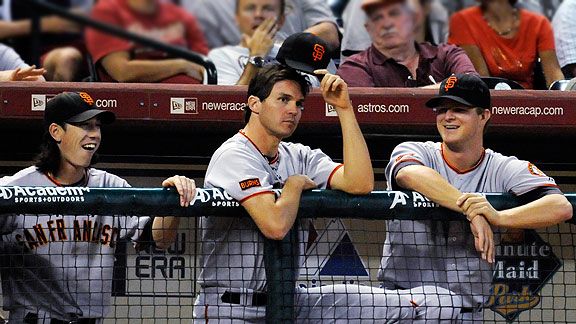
[{"left": 338, "top": 0, "right": 476, "bottom": 87}]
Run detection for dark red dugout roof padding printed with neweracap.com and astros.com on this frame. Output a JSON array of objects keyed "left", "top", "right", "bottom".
[{"left": 0, "top": 82, "right": 576, "bottom": 137}]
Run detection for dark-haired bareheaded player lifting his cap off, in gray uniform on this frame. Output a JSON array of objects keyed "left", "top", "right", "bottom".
[{"left": 194, "top": 65, "right": 459, "bottom": 323}]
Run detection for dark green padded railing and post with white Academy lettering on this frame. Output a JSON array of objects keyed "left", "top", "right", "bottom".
[{"left": 0, "top": 187, "right": 576, "bottom": 323}]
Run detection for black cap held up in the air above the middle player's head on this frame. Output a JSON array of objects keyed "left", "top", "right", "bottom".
[{"left": 276, "top": 33, "right": 332, "bottom": 74}]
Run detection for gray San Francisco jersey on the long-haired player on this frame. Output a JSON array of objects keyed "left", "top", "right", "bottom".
[{"left": 0, "top": 166, "right": 150, "bottom": 322}]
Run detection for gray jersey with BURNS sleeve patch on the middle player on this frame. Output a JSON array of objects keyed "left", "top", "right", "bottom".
[{"left": 198, "top": 133, "right": 341, "bottom": 290}]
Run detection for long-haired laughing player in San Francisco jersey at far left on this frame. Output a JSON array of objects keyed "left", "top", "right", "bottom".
[{"left": 0, "top": 92, "right": 195, "bottom": 324}]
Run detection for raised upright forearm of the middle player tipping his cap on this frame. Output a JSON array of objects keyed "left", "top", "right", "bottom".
[{"left": 338, "top": 109, "right": 374, "bottom": 194}]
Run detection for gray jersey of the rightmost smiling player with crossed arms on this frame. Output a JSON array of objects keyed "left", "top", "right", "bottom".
[{"left": 378, "top": 142, "right": 560, "bottom": 307}]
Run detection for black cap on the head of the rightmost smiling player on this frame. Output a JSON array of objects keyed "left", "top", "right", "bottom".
[{"left": 426, "top": 74, "right": 490, "bottom": 109}]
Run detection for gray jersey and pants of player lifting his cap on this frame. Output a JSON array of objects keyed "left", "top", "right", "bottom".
[{"left": 194, "top": 133, "right": 460, "bottom": 323}]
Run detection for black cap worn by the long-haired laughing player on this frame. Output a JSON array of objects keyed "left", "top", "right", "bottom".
[{"left": 44, "top": 92, "right": 116, "bottom": 127}]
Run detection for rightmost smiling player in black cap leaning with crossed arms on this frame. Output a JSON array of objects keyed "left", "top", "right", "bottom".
[{"left": 379, "top": 74, "right": 572, "bottom": 320}]
